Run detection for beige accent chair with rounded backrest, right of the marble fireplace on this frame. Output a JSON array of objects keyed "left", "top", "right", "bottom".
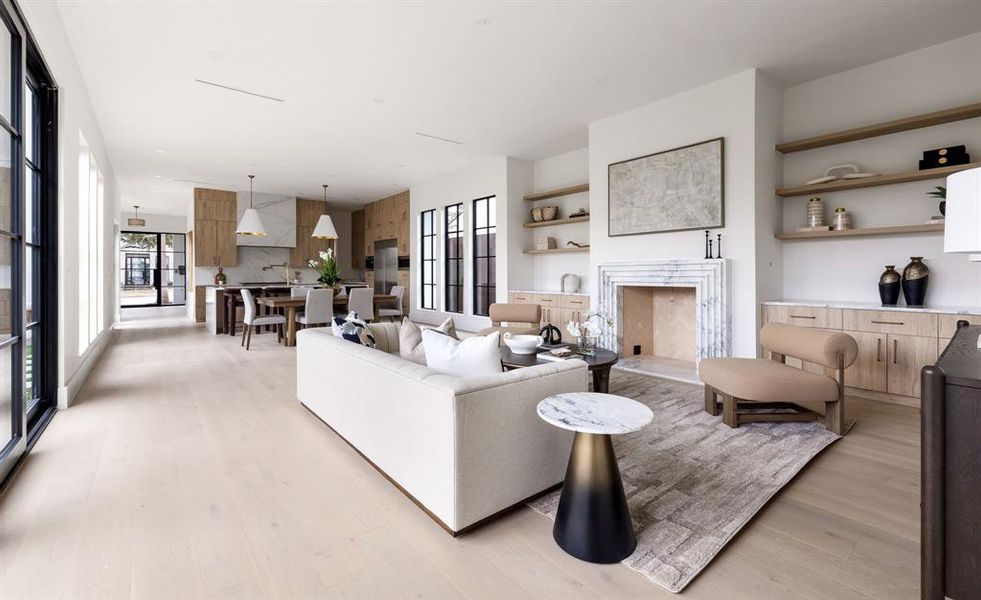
[{"left": 698, "top": 323, "right": 858, "bottom": 435}]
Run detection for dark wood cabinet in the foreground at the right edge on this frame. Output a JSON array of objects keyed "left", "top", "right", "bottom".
[{"left": 920, "top": 321, "right": 981, "bottom": 600}]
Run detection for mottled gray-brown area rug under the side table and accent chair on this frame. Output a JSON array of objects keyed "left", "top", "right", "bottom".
[{"left": 529, "top": 369, "right": 838, "bottom": 592}]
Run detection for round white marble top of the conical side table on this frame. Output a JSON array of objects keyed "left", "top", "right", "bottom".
[{"left": 538, "top": 392, "right": 654, "bottom": 434}]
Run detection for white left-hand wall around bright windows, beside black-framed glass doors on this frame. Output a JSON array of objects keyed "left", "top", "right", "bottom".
[{"left": 21, "top": 2, "right": 119, "bottom": 407}]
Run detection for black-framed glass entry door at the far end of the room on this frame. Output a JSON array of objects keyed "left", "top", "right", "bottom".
[{"left": 119, "top": 231, "right": 187, "bottom": 308}]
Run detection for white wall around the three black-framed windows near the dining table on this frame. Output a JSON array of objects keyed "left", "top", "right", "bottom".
[{"left": 409, "top": 156, "right": 532, "bottom": 331}]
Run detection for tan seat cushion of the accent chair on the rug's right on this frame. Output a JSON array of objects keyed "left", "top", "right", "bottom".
[{"left": 698, "top": 358, "right": 838, "bottom": 402}]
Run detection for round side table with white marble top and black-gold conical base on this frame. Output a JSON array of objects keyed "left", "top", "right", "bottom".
[{"left": 538, "top": 392, "right": 654, "bottom": 563}]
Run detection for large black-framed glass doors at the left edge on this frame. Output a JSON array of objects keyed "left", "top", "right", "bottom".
[{"left": 0, "top": 0, "right": 58, "bottom": 488}]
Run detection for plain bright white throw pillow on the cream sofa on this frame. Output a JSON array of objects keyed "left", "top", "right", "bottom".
[{"left": 422, "top": 329, "right": 501, "bottom": 377}]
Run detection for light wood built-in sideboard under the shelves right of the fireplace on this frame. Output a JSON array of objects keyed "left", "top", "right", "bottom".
[{"left": 761, "top": 301, "right": 981, "bottom": 407}]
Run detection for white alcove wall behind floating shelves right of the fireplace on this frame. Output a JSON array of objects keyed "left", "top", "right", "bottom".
[{"left": 782, "top": 33, "right": 981, "bottom": 307}]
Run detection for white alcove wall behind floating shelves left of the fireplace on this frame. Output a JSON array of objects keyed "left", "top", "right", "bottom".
[{"left": 528, "top": 147, "right": 591, "bottom": 292}]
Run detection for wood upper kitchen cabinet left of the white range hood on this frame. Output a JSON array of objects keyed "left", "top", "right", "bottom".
[{"left": 194, "top": 188, "right": 238, "bottom": 267}]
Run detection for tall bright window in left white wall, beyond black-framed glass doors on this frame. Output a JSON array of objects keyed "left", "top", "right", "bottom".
[{"left": 78, "top": 132, "right": 105, "bottom": 354}]
